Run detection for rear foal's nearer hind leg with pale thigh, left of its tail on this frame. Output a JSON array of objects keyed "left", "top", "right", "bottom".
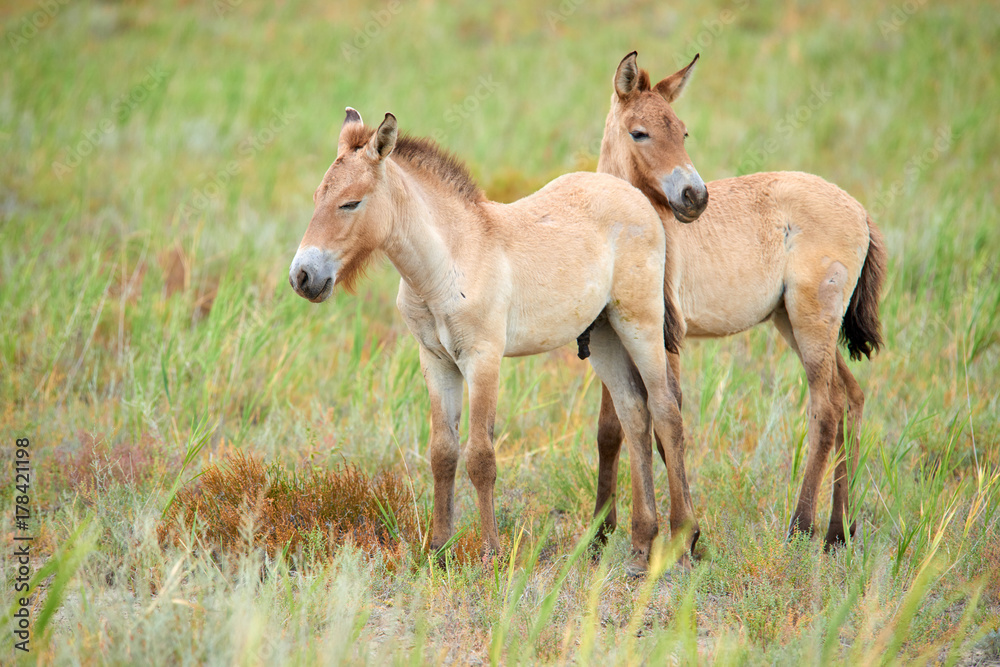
[{"left": 774, "top": 262, "right": 847, "bottom": 535}]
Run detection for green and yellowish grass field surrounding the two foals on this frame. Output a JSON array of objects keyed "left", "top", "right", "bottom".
[{"left": 0, "top": 0, "right": 1000, "bottom": 664}]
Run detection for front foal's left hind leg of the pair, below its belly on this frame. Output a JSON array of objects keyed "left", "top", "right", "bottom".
[{"left": 590, "top": 322, "right": 662, "bottom": 571}]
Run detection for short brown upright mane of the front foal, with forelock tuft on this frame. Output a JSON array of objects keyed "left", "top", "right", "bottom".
[{"left": 341, "top": 123, "right": 486, "bottom": 203}]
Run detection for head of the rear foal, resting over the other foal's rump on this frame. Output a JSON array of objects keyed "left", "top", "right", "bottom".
[{"left": 601, "top": 51, "right": 708, "bottom": 222}]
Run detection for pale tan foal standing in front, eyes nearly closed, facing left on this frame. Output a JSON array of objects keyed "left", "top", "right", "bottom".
[{"left": 289, "top": 108, "right": 708, "bottom": 570}]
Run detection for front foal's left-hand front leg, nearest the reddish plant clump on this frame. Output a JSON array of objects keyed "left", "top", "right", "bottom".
[{"left": 420, "top": 347, "right": 462, "bottom": 551}]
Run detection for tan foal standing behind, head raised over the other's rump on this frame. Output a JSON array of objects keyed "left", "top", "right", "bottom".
[{"left": 597, "top": 53, "right": 886, "bottom": 548}]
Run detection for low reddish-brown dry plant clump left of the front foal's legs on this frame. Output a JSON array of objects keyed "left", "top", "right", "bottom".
[{"left": 159, "top": 451, "right": 420, "bottom": 567}]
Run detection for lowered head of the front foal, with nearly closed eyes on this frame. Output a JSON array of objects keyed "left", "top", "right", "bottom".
[{"left": 288, "top": 107, "right": 397, "bottom": 303}]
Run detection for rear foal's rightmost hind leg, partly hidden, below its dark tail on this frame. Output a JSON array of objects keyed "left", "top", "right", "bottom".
[{"left": 826, "top": 350, "right": 865, "bottom": 550}]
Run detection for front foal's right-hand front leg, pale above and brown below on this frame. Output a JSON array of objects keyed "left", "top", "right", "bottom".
[{"left": 459, "top": 349, "right": 503, "bottom": 554}]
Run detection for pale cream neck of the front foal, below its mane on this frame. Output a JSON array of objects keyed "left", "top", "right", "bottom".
[{"left": 382, "top": 162, "right": 474, "bottom": 301}]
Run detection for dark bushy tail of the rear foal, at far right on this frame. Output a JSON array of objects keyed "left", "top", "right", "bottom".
[{"left": 840, "top": 215, "right": 886, "bottom": 359}]
